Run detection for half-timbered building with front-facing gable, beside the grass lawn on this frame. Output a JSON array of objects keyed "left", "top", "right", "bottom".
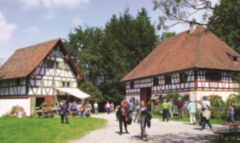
[{"left": 0, "top": 39, "right": 83, "bottom": 116}]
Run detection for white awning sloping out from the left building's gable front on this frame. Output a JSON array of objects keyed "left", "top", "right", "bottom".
[{"left": 57, "top": 87, "right": 90, "bottom": 99}]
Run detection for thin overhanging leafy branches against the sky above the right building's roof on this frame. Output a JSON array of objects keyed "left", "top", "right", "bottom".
[{"left": 153, "top": 0, "right": 217, "bottom": 29}]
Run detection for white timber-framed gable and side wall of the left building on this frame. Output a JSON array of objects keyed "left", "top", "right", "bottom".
[{"left": 0, "top": 45, "right": 78, "bottom": 99}]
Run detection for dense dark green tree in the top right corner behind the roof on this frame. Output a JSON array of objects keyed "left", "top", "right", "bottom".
[{"left": 208, "top": 0, "right": 240, "bottom": 51}]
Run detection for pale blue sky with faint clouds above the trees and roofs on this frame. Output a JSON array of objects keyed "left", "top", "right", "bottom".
[{"left": 0, "top": 0, "right": 191, "bottom": 61}]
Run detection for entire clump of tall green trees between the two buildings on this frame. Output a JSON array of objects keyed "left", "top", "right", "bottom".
[{"left": 66, "top": 9, "right": 157, "bottom": 101}]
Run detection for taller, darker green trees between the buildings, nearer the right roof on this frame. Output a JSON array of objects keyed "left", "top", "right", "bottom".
[{"left": 100, "top": 9, "right": 156, "bottom": 101}]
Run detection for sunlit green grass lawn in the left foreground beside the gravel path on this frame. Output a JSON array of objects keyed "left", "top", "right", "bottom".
[{"left": 0, "top": 118, "right": 107, "bottom": 143}]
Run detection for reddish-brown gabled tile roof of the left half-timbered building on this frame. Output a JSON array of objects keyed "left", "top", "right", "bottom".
[{"left": 0, "top": 39, "right": 82, "bottom": 80}]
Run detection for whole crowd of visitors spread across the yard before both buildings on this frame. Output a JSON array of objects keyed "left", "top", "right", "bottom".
[{"left": 59, "top": 97, "right": 235, "bottom": 140}]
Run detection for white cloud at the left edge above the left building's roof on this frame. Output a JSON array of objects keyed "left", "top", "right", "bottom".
[{"left": 0, "top": 11, "right": 17, "bottom": 42}]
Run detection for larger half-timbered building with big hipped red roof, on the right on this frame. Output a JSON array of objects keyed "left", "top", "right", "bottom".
[{"left": 122, "top": 26, "right": 240, "bottom": 104}]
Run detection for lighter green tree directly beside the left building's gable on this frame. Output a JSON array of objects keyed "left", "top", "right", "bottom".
[{"left": 65, "top": 27, "right": 104, "bottom": 101}]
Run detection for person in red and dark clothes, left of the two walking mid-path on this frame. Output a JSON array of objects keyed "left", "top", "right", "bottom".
[{"left": 117, "top": 101, "right": 128, "bottom": 135}]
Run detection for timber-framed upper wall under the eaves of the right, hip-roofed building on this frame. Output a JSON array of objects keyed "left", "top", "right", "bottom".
[{"left": 126, "top": 69, "right": 240, "bottom": 96}]
